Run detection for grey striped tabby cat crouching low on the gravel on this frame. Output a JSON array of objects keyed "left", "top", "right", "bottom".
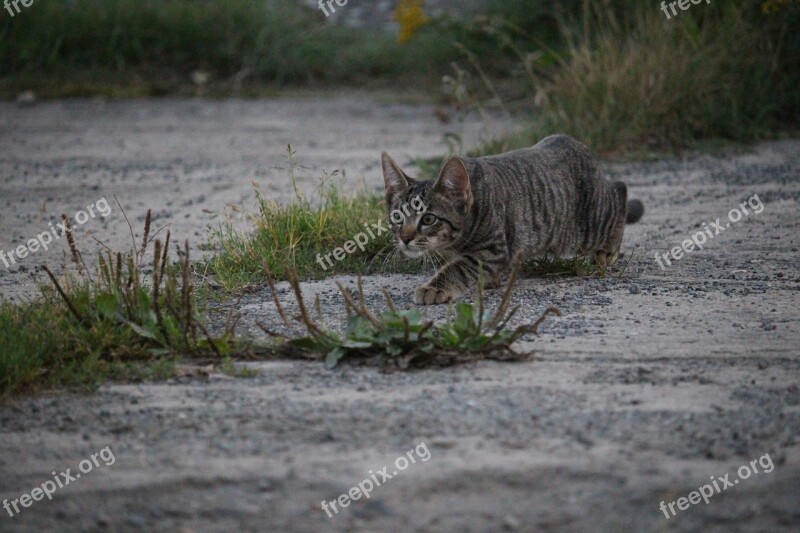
[{"left": 381, "top": 135, "right": 644, "bottom": 305}]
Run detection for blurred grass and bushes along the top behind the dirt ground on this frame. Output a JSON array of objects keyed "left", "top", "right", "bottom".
[{"left": 0, "top": 0, "right": 800, "bottom": 152}]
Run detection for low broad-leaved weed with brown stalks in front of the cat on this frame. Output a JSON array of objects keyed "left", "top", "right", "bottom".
[{"left": 259, "top": 265, "right": 560, "bottom": 369}]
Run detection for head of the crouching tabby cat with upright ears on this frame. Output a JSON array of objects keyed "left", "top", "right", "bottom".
[{"left": 381, "top": 152, "right": 472, "bottom": 257}]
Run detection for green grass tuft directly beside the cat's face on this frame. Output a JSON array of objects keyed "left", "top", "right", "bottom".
[{"left": 208, "top": 147, "right": 420, "bottom": 289}]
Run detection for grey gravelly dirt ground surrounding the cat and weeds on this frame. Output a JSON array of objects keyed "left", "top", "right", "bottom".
[{"left": 0, "top": 95, "right": 800, "bottom": 532}]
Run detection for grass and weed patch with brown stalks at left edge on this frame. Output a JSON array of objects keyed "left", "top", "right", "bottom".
[{"left": 0, "top": 206, "right": 234, "bottom": 394}]
